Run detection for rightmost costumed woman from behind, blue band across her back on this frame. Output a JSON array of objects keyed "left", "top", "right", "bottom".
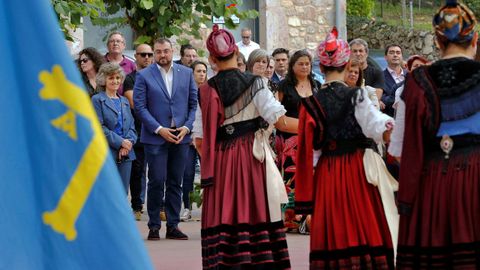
[{"left": 397, "top": 0, "right": 480, "bottom": 269}]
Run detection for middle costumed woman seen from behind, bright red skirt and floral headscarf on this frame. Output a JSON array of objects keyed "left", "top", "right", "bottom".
[{"left": 295, "top": 28, "right": 398, "bottom": 269}]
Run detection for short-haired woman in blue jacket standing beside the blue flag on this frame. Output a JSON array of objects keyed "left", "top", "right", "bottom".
[{"left": 92, "top": 62, "right": 137, "bottom": 195}]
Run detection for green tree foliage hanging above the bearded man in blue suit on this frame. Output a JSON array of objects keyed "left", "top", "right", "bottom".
[{"left": 93, "top": 0, "right": 258, "bottom": 43}]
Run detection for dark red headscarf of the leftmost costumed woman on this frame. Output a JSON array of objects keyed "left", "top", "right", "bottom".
[{"left": 207, "top": 24, "right": 237, "bottom": 57}]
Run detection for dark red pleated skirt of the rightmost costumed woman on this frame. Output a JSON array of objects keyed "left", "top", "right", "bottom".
[{"left": 397, "top": 148, "right": 480, "bottom": 269}]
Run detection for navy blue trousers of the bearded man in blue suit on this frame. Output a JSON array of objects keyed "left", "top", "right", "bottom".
[{"left": 144, "top": 142, "right": 189, "bottom": 229}]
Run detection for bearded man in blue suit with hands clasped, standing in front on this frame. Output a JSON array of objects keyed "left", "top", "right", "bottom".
[{"left": 133, "top": 38, "right": 197, "bottom": 240}]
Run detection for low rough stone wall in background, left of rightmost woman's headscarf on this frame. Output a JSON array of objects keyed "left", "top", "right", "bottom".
[{"left": 347, "top": 21, "right": 438, "bottom": 60}]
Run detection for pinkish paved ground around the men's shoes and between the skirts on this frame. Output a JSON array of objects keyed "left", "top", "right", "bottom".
[{"left": 133, "top": 210, "right": 310, "bottom": 270}]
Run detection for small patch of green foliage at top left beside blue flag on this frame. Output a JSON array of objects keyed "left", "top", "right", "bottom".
[{"left": 50, "top": 0, "right": 106, "bottom": 41}]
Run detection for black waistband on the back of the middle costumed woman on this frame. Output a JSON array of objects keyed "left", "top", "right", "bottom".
[{"left": 322, "top": 138, "right": 378, "bottom": 156}]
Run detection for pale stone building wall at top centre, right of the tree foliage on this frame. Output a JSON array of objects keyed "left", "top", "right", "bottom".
[{"left": 260, "top": 0, "right": 335, "bottom": 51}]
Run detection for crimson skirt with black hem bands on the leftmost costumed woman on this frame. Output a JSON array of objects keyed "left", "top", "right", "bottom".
[{"left": 202, "top": 133, "right": 290, "bottom": 269}]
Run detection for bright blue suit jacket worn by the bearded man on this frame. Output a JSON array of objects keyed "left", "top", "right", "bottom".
[{"left": 133, "top": 63, "right": 198, "bottom": 145}]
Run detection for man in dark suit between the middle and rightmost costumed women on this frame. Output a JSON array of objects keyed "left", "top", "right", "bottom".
[{"left": 382, "top": 44, "right": 406, "bottom": 116}]
